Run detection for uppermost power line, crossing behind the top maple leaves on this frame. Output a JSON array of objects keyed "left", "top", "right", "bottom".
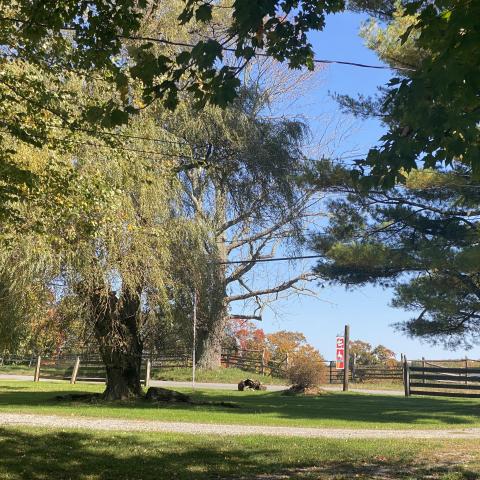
[{"left": 0, "top": 17, "right": 415, "bottom": 71}]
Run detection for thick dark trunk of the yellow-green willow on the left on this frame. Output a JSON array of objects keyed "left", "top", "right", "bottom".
[{"left": 91, "top": 292, "right": 143, "bottom": 400}]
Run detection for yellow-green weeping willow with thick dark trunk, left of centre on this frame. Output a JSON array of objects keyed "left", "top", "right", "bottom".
[{"left": 0, "top": 108, "right": 210, "bottom": 399}]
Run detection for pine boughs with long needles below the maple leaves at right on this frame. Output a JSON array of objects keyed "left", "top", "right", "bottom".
[{"left": 311, "top": 159, "right": 480, "bottom": 346}]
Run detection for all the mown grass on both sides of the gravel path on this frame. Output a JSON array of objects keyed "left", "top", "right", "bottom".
[{"left": 0, "top": 381, "right": 480, "bottom": 480}]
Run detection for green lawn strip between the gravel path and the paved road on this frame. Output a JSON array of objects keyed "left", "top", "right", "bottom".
[{"left": 0, "top": 381, "right": 480, "bottom": 429}]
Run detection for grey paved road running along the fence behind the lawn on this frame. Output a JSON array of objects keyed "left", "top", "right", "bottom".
[{"left": 0, "top": 374, "right": 404, "bottom": 395}]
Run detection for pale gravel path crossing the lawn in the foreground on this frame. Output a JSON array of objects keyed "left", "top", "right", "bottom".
[{"left": 0, "top": 413, "right": 480, "bottom": 439}]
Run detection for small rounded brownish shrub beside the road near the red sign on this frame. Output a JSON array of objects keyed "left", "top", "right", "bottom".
[{"left": 287, "top": 345, "right": 327, "bottom": 390}]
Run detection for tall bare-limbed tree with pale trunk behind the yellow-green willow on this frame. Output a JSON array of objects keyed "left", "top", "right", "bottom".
[{"left": 152, "top": 69, "right": 322, "bottom": 368}]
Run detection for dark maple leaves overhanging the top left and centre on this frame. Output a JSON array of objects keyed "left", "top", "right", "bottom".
[{"left": 0, "top": 0, "right": 345, "bottom": 125}]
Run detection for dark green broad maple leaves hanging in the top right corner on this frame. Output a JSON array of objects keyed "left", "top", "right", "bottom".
[{"left": 363, "top": 0, "right": 480, "bottom": 188}]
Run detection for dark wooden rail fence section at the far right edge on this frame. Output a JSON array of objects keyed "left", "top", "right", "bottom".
[{"left": 403, "top": 359, "right": 480, "bottom": 398}]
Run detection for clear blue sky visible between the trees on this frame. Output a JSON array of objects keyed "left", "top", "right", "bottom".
[{"left": 234, "top": 13, "right": 480, "bottom": 359}]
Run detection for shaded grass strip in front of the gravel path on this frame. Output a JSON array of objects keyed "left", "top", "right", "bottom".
[{"left": 0, "top": 427, "right": 480, "bottom": 480}]
